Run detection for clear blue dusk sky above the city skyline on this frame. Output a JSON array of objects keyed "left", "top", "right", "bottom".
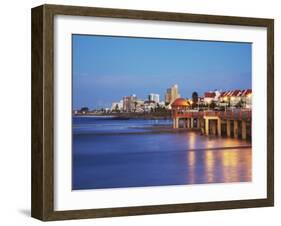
[{"left": 72, "top": 35, "right": 252, "bottom": 109}]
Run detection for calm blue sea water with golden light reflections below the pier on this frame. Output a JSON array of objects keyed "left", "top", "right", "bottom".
[{"left": 72, "top": 117, "right": 252, "bottom": 190}]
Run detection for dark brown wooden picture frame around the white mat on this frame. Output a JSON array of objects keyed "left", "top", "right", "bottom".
[{"left": 31, "top": 5, "right": 274, "bottom": 221}]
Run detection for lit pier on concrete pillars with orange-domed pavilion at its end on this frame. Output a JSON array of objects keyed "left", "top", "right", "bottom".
[{"left": 172, "top": 101, "right": 252, "bottom": 140}]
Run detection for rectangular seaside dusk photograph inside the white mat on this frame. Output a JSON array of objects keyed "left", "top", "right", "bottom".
[{"left": 72, "top": 34, "right": 250, "bottom": 190}]
